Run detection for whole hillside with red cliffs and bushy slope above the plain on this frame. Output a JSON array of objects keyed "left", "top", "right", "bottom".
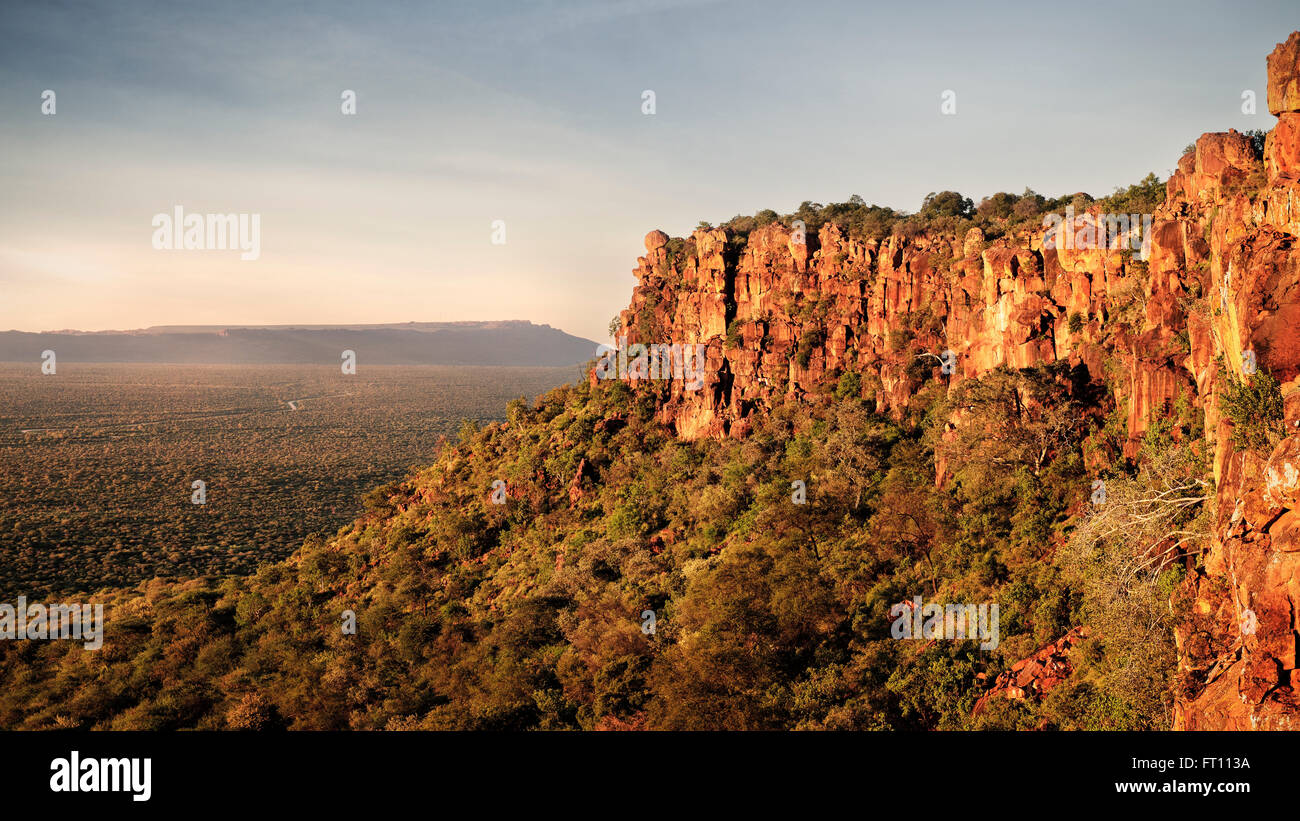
[{"left": 0, "top": 32, "right": 1300, "bottom": 729}]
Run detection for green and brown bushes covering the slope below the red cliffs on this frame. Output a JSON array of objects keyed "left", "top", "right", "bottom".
[{"left": 0, "top": 353, "right": 1206, "bottom": 729}]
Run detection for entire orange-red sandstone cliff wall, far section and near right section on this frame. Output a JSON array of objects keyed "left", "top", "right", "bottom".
[{"left": 605, "top": 32, "right": 1300, "bottom": 729}]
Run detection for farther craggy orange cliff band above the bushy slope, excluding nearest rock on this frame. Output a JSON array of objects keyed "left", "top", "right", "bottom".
[{"left": 620, "top": 210, "right": 1190, "bottom": 449}]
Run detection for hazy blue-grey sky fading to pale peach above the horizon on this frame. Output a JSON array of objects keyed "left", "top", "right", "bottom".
[{"left": 0, "top": 0, "right": 1300, "bottom": 340}]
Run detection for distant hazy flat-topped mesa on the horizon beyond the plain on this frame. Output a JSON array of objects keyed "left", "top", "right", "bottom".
[{"left": 0, "top": 320, "right": 597, "bottom": 368}]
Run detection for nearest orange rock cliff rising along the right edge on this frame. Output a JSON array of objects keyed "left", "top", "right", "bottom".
[{"left": 1169, "top": 32, "right": 1300, "bottom": 730}]
